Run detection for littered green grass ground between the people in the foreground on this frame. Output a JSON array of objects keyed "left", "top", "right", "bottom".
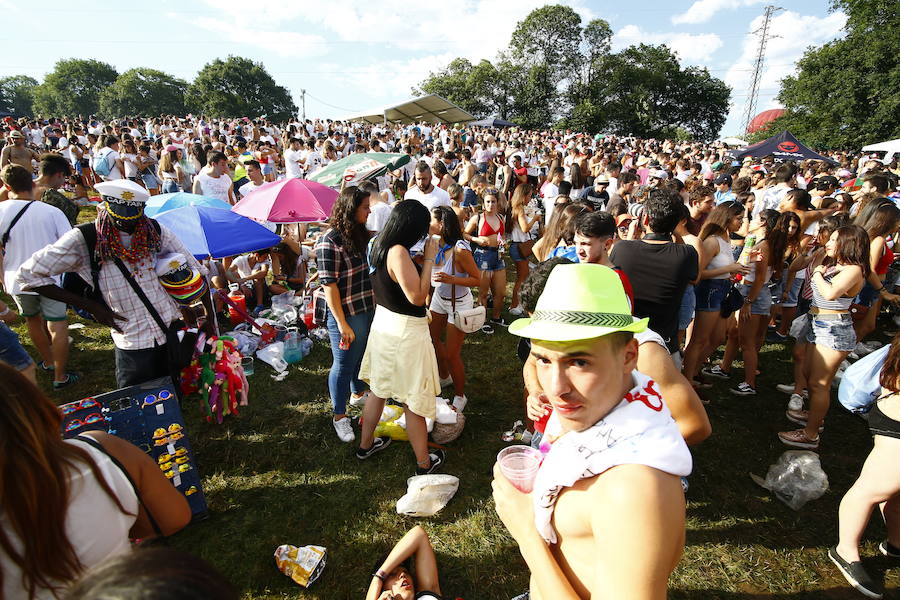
[{"left": 4, "top": 205, "right": 900, "bottom": 600}]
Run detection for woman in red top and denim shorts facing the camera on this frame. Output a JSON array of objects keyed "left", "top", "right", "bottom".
[{"left": 465, "top": 190, "right": 508, "bottom": 334}]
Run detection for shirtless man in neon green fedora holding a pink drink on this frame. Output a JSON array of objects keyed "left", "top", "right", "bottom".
[{"left": 493, "top": 264, "right": 691, "bottom": 600}]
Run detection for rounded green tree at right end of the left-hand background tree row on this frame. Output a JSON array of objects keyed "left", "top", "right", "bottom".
[{"left": 185, "top": 56, "right": 297, "bottom": 120}]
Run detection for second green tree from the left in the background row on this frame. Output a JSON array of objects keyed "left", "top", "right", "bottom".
[{"left": 34, "top": 58, "right": 118, "bottom": 116}]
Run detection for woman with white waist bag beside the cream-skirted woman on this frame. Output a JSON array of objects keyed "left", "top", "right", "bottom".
[{"left": 428, "top": 206, "right": 481, "bottom": 412}]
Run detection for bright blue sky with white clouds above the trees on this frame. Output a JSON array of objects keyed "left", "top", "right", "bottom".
[{"left": 0, "top": 0, "right": 846, "bottom": 136}]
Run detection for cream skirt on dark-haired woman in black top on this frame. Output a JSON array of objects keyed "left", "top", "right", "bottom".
[{"left": 359, "top": 305, "right": 441, "bottom": 419}]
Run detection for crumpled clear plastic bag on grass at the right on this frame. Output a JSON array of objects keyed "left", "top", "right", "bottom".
[{"left": 750, "top": 450, "right": 828, "bottom": 510}]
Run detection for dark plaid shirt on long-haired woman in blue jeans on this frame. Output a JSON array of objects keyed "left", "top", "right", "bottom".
[{"left": 316, "top": 229, "right": 375, "bottom": 315}]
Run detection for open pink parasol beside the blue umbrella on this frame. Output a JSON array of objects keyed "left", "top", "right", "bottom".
[{"left": 231, "top": 178, "right": 338, "bottom": 223}]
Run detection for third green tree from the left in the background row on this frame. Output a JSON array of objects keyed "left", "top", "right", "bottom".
[{"left": 100, "top": 68, "right": 188, "bottom": 117}]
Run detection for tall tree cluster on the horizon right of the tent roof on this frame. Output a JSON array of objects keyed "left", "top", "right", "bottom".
[{"left": 413, "top": 5, "right": 731, "bottom": 140}]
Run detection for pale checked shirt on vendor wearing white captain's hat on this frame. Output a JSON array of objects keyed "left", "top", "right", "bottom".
[{"left": 16, "top": 225, "right": 206, "bottom": 350}]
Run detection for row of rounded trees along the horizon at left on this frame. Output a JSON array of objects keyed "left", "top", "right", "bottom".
[{"left": 0, "top": 56, "right": 297, "bottom": 121}]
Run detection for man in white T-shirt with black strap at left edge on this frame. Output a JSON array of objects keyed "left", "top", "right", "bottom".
[{"left": 0, "top": 165, "right": 78, "bottom": 389}]
